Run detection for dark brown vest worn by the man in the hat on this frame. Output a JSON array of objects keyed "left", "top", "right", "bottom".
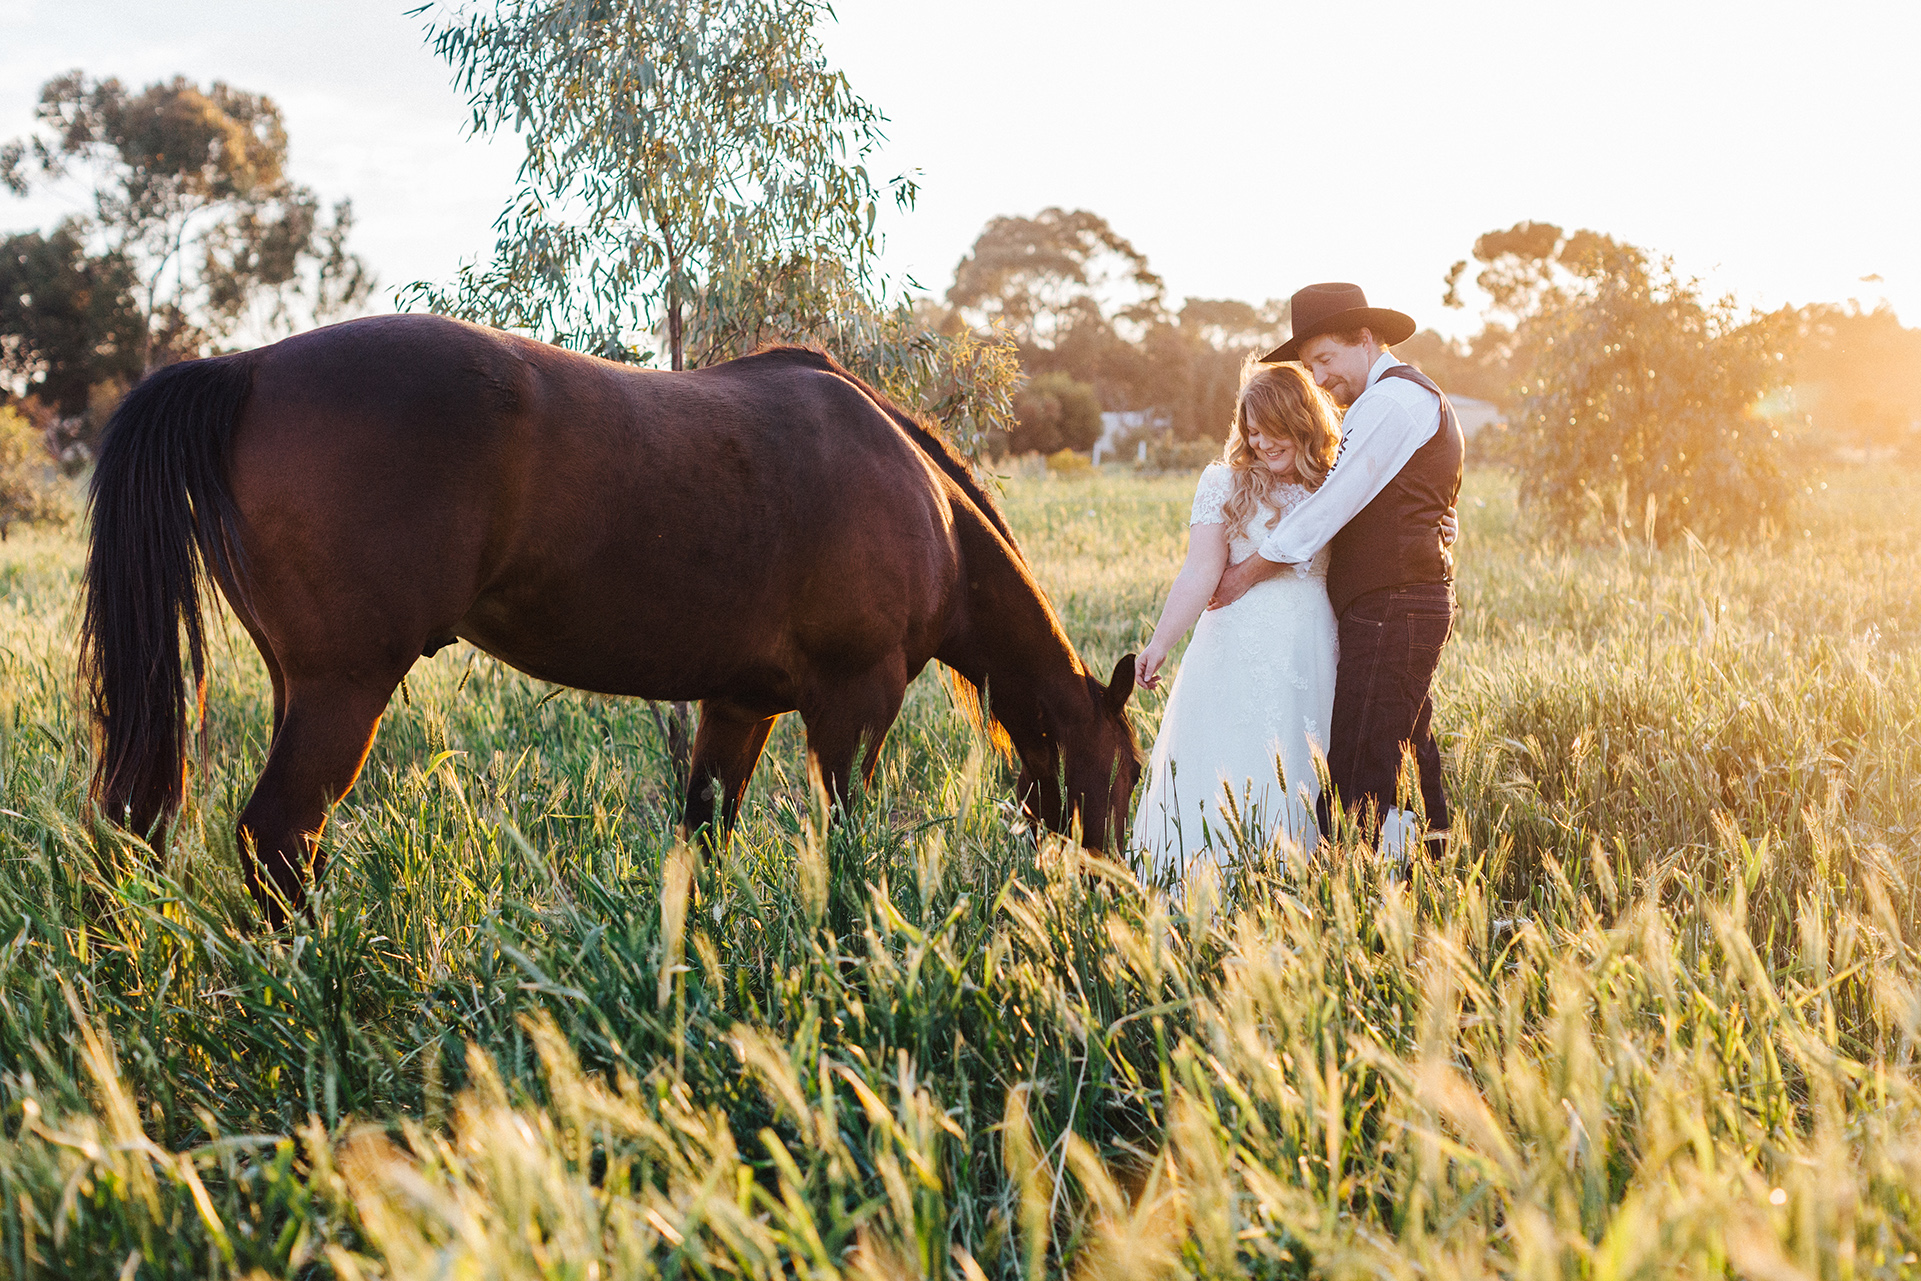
[{"left": 1327, "top": 365, "right": 1464, "bottom": 616}]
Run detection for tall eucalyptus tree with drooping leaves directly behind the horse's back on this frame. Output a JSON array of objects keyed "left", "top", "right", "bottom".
[{"left": 403, "top": 0, "right": 1018, "bottom": 787}]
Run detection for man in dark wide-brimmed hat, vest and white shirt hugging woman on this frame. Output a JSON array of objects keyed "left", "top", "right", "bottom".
[{"left": 1208, "top": 284, "right": 1462, "bottom": 853}]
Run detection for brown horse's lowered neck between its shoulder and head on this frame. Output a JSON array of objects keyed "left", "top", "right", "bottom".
[{"left": 937, "top": 513, "right": 1085, "bottom": 762}]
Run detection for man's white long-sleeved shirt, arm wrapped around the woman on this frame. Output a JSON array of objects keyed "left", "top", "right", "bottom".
[{"left": 1260, "top": 351, "right": 1441, "bottom": 565}]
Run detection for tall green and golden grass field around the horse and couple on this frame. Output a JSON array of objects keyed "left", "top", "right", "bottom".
[{"left": 0, "top": 462, "right": 1921, "bottom": 1279}]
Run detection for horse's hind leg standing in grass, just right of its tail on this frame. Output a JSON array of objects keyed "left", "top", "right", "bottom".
[{"left": 238, "top": 678, "right": 400, "bottom": 928}]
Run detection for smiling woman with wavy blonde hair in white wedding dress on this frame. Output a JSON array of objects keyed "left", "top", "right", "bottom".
[{"left": 1133, "top": 365, "right": 1341, "bottom": 876}]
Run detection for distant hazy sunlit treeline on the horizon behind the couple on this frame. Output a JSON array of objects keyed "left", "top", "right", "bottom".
[{"left": 922, "top": 207, "right": 1921, "bottom": 474}]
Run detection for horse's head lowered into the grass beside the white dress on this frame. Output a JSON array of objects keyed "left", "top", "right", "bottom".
[{"left": 1016, "top": 653, "right": 1141, "bottom": 849}]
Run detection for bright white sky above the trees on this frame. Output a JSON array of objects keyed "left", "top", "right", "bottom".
[{"left": 0, "top": 0, "right": 1921, "bottom": 332}]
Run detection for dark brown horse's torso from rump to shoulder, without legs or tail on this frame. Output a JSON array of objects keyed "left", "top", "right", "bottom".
[{"left": 232, "top": 317, "right": 957, "bottom": 697}]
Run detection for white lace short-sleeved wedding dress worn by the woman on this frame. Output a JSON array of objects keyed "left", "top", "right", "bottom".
[{"left": 1133, "top": 463, "right": 1339, "bottom": 876}]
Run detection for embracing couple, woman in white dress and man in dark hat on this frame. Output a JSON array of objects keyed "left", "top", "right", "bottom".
[{"left": 1133, "top": 284, "right": 1462, "bottom": 876}]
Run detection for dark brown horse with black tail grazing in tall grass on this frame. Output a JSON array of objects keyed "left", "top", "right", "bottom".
[{"left": 81, "top": 317, "right": 1139, "bottom": 922}]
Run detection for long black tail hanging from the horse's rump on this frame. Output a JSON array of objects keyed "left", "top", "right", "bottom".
[{"left": 81, "top": 355, "right": 254, "bottom": 835}]
